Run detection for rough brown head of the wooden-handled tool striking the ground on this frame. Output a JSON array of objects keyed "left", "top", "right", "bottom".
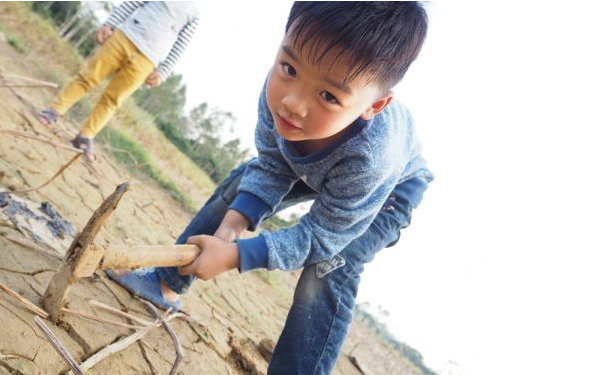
[{"left": 43, "top": 182, "right": 128, "bottom": 323}]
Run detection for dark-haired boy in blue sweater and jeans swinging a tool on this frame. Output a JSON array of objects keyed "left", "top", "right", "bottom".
[{"left": 108, "top": 2, "right": 432, "bottom": 374}]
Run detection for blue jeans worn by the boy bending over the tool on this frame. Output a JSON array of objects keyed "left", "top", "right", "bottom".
[{"left": 157, "top": 164, "right": 411, "bottom": 375}]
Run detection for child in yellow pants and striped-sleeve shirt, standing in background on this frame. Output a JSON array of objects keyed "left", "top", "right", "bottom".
[{"left": 38, "top": 1, "right": 199, "bottom": 161}]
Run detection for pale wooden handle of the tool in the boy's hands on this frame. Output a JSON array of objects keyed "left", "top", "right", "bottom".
[{"left": 99, "top": 245, "right": 200, "bottom": 269}]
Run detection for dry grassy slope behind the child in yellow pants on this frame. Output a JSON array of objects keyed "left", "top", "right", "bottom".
[{"left": 0, "top": 2, "right": 215, "bottom": 211}]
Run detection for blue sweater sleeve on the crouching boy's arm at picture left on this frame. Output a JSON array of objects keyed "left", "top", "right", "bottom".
[{"left": 230, "top": 82, "right": 298, "bottom": 230}]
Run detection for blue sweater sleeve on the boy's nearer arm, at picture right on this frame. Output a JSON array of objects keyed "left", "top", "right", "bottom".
[{"left": 238, "top": 157, "right": 397, "bottom": 272}]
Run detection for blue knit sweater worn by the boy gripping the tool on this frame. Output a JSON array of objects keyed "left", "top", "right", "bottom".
[{"left": 230, "top": 83, "right": 433, "bottom": 272}]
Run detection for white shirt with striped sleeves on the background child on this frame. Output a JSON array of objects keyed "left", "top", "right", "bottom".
[{"left": 105, "top": 1, "right": 200, "bottom": 80}]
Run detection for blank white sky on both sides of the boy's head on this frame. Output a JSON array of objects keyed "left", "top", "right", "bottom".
[{"left": 172, "top": 1, "right": 613, "bottom": 375}]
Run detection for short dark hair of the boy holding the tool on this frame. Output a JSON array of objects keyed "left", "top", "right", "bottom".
[{"left": 285, "top": 1, "right": 428, "bottom": 91}]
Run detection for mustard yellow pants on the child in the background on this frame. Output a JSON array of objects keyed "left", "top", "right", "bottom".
[{"left": 52, "top": 29, "right": 155, "bottom": 138}]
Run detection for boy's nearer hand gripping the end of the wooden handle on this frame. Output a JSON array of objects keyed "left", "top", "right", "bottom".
[{"left": 179, "top": 235, "right": 240, "bottom": 280}]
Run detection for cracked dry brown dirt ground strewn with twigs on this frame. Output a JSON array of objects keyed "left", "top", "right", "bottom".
[{"left": 0, "top": 30, "right": 413, "bottom": 375}]
